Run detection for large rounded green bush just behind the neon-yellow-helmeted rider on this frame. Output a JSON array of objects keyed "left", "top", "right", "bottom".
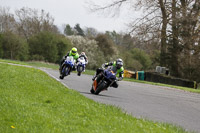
[{"left": 28, "top": 32, "right": 72, "bottom": 63}]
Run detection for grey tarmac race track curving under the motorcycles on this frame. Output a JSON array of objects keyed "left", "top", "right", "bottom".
[{"left": 42, "top": 68, "right": 200, "bottom": 133}]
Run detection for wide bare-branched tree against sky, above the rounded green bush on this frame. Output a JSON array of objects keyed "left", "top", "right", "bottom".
[{"left": 15, "top": 8, "right": 59, "bottom": 40}]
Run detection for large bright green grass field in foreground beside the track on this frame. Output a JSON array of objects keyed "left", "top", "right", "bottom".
[{"left": 0, "top": 64, "right": 191, "bottom": 133}]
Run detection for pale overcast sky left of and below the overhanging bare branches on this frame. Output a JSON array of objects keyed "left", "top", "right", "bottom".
[{"left": 0, "top": 0, "right": 137, "bottom": 32}]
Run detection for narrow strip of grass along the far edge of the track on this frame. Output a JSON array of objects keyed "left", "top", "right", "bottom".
[{"left": 0, "top": 59, "right": 200, "bottom": 93}]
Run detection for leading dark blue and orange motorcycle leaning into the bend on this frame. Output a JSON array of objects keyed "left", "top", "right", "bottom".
[{"left": 90, "top": 68, "right": 116, "bottom": 95}]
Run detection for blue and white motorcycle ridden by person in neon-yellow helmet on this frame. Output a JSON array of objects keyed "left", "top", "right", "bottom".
[{"left": 60, "top": 56, "right": 75, "bottom": 79}]
